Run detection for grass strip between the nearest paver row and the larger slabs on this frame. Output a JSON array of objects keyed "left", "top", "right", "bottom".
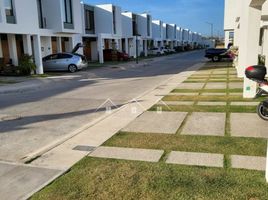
[{"left": 104, "top": 132, "right": 267, "bottom": 156}]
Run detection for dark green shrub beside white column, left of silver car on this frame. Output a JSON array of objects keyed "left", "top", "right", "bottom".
[{"left": 19, "top": 54, "right": 36, "bottom": 75}]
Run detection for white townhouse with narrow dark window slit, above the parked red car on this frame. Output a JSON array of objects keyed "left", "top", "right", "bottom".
[{"left": 94, "top": 4, "right": 122, "bottom": 63}]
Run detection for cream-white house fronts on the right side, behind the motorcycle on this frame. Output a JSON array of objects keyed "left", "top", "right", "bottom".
[{"left": 224, "top": 0, "right": 268, "bottom": 98}]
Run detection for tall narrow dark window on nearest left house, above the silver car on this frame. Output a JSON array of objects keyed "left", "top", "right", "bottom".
[{"left": 62, "top": 0, "right": 74, "bottom": 29}]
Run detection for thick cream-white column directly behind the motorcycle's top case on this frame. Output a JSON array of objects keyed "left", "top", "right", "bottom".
[{"left": 238, "top": 0, "right": 261, "bottom": 98}]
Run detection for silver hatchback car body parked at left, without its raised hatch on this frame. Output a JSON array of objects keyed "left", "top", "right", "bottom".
[{"left": 43, "top": 53, "right": 88, "bottom": 73}]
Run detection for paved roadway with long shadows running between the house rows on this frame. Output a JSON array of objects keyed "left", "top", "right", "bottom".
[{"left": 0, "top": 51, "right": 204, "bottom": 162}]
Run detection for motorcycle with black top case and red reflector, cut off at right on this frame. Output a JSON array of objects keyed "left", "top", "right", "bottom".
[{"left": 245, "top": 65, "right": 268, "bottom": 121}]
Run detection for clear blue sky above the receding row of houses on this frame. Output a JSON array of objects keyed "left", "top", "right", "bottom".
[{"left": 85, "top": 0, "right": 224, "bottom": 35}]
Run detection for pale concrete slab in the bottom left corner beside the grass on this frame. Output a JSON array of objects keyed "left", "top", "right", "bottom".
[{"left": 0, "top": 162, "right": 64, "bottom": 200}]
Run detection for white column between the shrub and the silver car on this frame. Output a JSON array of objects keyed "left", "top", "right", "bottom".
[{"left": 33, "top": 35, "right": 44, "bottom": 74}]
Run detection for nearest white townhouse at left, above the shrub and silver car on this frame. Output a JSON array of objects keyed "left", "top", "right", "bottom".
[{"left": 0, "top": 0, "right": 82, "bottom": 74}]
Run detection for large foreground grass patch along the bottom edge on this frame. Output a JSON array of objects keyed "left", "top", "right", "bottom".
[{"left": 32, "top": 158, "right": 268, "bottom": 200}]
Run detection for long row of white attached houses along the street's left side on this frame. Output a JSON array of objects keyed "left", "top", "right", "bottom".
[{"left": 0, "top": 0, "right": 203, "bottom": 74}]
